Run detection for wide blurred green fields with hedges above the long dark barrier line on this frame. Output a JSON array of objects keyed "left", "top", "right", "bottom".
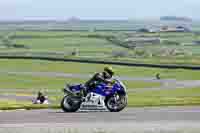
[{"left": 0, "top": 31, "right": 200, "bottom": 65}]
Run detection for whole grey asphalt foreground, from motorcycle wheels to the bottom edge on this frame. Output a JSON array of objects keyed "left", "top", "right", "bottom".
[{"left": 0, "top": 107, "right": 200, "bottom": 133}]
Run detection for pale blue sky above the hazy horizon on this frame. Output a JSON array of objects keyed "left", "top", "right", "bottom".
[{"left": 0, "top": 0, "right": 200, "bottom": 20}]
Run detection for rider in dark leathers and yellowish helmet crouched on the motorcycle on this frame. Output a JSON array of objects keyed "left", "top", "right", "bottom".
[{"left": 85, "top": 67, "right": 114, "bottom": 92}]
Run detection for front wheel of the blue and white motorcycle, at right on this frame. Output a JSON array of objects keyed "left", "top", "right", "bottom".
[{"left": 105, "top": 95, "right": 127, "bottom": 112}]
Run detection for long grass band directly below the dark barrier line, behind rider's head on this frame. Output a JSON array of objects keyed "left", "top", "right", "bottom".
[{"left": 0, "top": 59, "right": 200, "bottom": 80}]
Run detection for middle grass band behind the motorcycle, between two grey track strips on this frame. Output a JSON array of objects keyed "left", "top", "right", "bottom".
[{"left": 0, "top": 74, "right": 161, "bottom": 92}]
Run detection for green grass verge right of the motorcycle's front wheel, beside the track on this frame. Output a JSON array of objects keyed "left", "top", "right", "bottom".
[{"left": 129, "top": 88, "right": 200, "bottom": 107}]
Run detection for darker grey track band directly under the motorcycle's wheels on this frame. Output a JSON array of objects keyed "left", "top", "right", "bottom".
[{"left": 0, "top": 107, "right": 200, "bottom": 124}]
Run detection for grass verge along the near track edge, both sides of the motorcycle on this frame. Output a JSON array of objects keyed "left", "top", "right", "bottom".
[{"left": 0, "top": 88, "right": 200, "bottom": 110}]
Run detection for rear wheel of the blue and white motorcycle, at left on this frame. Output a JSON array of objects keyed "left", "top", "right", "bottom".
[{"left": 61, "top": 95, "right": 82, "bottom": 112}]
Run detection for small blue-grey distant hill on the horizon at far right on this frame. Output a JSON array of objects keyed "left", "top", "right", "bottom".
[{"left": 160, "top": 16, "right": 192, "bottom": 22}]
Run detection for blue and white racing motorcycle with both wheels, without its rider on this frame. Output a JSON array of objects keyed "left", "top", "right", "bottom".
[{"left": 61, "top": 79, "right": 128, "bottom": 112}]
